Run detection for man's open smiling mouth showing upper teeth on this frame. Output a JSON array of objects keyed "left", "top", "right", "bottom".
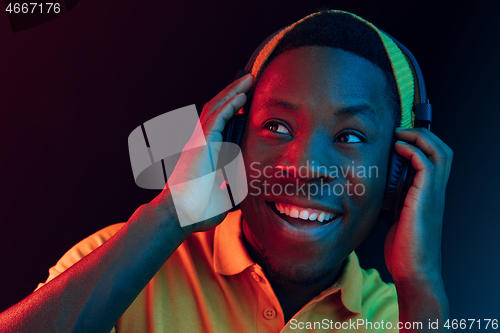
[{"left": 266, "top": 201, "right": 341, "bottom": 229}]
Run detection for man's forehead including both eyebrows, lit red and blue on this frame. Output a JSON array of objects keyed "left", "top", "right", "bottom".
[{"left": 252, "top": 46, "right": 386, "bottom": 121}]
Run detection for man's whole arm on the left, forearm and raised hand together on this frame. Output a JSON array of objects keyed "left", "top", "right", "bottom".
[{"left": 0, "top": 75, "right": 253, "bottom": 332}]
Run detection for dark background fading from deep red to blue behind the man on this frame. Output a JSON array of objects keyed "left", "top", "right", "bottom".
[{"left": 0, "top": 0, "right": 500, "bottom": 319}]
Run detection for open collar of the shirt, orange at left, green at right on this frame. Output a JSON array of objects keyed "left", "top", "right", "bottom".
[{"left": 213, "top": 210, "right": 363, "bottom": 314}]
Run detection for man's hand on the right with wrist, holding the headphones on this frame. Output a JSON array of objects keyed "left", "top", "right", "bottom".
[{"left": 385, "top": 128, "right": 453, "bottom": 284}]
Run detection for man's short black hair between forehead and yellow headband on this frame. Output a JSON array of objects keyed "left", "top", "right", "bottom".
[{"left": 252, "top": 10, "right": 401, "bottom": 126}]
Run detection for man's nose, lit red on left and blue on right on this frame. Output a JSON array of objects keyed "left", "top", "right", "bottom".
[{"left": 276, "top": 134, "right": 336, "bottom": 182}]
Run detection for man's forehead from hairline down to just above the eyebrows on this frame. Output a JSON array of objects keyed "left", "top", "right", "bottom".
[{"left": 255, "top": 46, "right": 386, "bottom": 99}]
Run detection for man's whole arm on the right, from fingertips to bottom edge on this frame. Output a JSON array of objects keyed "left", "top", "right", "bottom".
[{"left": 385, "top": 128, "right": 453, "bottom": 332}]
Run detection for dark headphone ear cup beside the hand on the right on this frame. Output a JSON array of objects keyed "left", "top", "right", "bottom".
[{"left": 382, "top": 148, "right": 415, "bottom": 211}]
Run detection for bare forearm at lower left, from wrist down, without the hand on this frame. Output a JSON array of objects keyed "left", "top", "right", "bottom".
[{"left": 0, "top": 195, "right": 189, "bottom": 332}]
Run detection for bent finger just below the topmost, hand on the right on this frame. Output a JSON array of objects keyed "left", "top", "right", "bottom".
[{"left": 395, "top": 141, "right": 436, "bottom": 189}]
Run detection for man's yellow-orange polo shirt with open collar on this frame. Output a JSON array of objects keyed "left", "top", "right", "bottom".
[{"left": 38, "top": 211, "right": 398, "bottom": 333}]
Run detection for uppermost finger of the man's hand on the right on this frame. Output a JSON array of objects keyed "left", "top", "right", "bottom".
[{"left": 396, "top": 128, "right": 451, "bottom": 184}]
